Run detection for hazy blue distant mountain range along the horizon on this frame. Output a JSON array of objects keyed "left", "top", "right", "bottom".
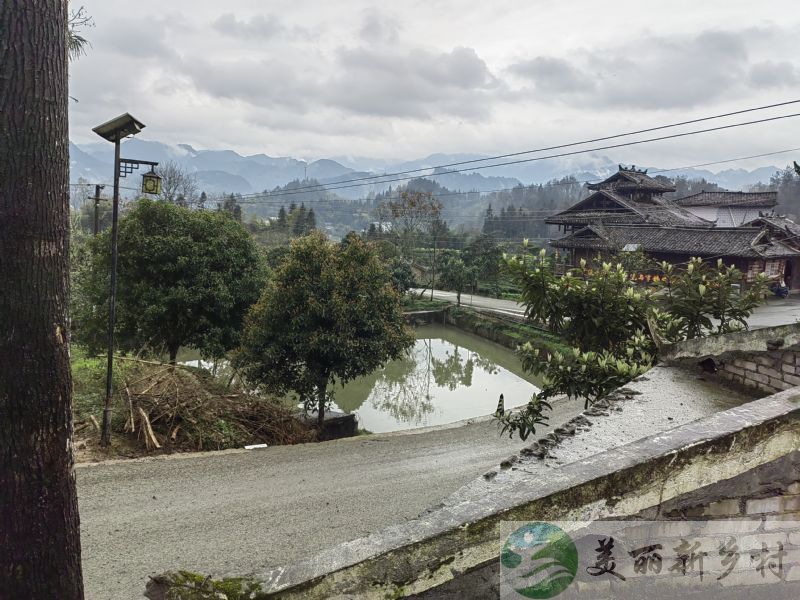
[{"left": 70, "top": 138, "right": 778, "bottom": 199}]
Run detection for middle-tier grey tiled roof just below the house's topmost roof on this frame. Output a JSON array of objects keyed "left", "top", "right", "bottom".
[{"left": 545, "top": 189, "right": 710, "bottom": 226}]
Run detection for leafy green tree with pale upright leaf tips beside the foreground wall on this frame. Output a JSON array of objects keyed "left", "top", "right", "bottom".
[{"left": 497, "top": 250, "right": 766, "bottom": 437}]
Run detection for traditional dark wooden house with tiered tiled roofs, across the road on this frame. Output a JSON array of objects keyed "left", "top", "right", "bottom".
[{"left": 546, "top": 166, "right": 800, "bottom": 288}]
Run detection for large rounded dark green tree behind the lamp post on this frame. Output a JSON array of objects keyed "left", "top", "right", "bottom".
[{"left": 75, "top": 200, "right": 264, "bottom": 362}]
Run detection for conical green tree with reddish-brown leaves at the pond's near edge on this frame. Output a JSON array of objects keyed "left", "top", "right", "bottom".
[{"left": 235, "top": 232, "right": 414, "bottom": 427}]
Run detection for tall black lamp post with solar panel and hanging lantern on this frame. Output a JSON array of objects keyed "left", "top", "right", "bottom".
[{"left": 92, "top": 113, "right": 161, "bottom": 446}]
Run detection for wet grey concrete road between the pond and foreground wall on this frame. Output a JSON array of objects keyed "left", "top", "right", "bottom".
[{"left": 77, "top": 400, "right": 582, "bottom": 600}]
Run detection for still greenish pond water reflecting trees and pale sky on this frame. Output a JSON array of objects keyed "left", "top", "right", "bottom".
[{"left": 328, "top": 326, "right": 537, "bottom": 432}]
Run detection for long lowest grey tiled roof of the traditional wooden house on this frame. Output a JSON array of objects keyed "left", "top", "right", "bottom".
[{"left": 552, "top": 225, "right": 800, "bottom": 258}]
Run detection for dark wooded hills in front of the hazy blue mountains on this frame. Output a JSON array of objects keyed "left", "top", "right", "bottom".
[{"left": 79, "top": 166, "right": 800, "bottom": 247}]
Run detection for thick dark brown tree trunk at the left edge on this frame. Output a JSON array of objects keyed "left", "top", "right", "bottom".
[{"left": 0, "top": 0, "right": 83, "bottom": 600}]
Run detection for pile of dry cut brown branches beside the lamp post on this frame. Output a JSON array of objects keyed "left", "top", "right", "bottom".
[{"left": 120, "top": 361, "right": 315, "bottom": 451}]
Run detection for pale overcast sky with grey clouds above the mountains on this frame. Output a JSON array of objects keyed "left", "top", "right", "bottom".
[{"left": 70, "top": 0, "right": 800, "bottom": 167}]
